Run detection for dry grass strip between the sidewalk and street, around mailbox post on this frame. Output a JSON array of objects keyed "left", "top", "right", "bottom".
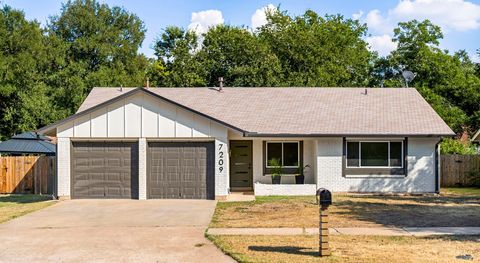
[{"left": 208, "top": 235, "right": 480, "bottom": 263}]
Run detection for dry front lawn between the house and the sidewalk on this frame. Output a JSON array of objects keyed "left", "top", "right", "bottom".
[{"left": 210, "top": 188, "right": 480, "bottom": 227}]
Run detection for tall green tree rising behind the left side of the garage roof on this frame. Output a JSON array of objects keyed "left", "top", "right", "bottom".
[{"left": 48, "top": 0, "right": 148, "bottom": 113}]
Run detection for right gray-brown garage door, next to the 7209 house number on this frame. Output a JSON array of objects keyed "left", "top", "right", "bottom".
[{"left": 147, "top": 142, "right": 215, "bottom": 199}]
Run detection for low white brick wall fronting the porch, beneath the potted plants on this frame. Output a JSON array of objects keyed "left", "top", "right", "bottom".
[{"left": 253, "top": 183, "right": 317, "bottom": 196}]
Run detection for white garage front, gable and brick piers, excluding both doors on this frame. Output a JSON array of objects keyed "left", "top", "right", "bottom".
[{"left": 57, "top": 93, "right": 229, "bottom": 199}]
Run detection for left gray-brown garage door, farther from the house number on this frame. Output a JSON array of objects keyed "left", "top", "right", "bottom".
[{"left": 71, "top": 142, "right": 138, "bottom": 198}]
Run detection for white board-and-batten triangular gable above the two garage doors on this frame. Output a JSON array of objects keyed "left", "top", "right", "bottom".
[{"left": 57, "top": 92, "right": 227, "bottom": 138}]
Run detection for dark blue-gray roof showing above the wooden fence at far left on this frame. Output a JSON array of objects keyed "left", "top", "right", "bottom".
[{"left": 0, "top": 132, "right": 56, "bottom": 155}]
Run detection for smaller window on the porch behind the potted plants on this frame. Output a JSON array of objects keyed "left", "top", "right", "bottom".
[{"left": 266, "top": 142, "right": 300, "bottom": 167}]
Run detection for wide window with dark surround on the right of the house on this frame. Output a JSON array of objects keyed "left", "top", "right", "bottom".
[{"left": 347, "top": 141, "right": 403, "bottom": 167}]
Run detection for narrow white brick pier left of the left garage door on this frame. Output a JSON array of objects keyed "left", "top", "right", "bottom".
[{"left": 57, "top": 138, "right": 70, "bottom": 197}]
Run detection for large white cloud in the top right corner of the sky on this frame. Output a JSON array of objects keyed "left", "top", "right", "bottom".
[{"left": 364, "top": 0, "right": 480, "bottom": 34}]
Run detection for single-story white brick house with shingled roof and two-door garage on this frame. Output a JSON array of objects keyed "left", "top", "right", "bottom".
[{"left": 38, "top": 88, "right": 454, "bottom": 199}]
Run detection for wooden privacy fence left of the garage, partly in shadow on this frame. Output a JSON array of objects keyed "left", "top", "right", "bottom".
[{"left": 0, "top": 156, "right": 56, "bottom": 194}]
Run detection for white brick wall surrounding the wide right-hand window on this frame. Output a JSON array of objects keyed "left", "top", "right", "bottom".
[{"left": 317, "top": 138, "right": 437, "bottom": 193}]
